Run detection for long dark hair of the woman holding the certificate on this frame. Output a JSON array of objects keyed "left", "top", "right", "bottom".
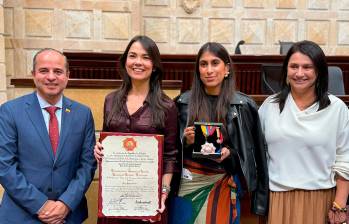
[{"left": 107, "top": 35, "right": 170, "bottom": 129}]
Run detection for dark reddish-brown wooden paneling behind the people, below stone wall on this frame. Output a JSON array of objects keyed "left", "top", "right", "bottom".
[{"left": 65, "top": 52, "right": 349, "bottom": 94}]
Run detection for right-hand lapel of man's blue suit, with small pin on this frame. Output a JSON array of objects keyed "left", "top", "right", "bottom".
[{"left": 56, "top": 97, "right": 74, "bottom": 161}]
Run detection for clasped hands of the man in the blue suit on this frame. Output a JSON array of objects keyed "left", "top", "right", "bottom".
[{"left": 39, "top": 200, "right": 69, "bottom": 224}]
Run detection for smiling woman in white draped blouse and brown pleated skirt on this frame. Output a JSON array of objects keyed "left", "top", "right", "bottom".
[{"left": 259, "top": 41, "right": 349, "bottom": 224}]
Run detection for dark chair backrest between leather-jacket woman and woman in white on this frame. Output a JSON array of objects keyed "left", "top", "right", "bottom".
[{"left": 261, "top": 64, "right": 282, "bottom": 94}]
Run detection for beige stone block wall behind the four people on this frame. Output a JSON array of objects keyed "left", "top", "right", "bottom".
[{"left": 0, "top": 0, "right": 349, "bottom": 99}]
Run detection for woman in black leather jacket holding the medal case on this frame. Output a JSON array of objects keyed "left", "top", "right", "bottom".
[{"left": 170, "top": 42, "right": 268, "bottom": 224}]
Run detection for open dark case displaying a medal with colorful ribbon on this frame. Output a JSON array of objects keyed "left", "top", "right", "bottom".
[{"left": 193, "top": 122, "right": 223, "bottom": 159}]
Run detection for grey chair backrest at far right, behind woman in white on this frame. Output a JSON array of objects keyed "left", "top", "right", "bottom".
[{"left": 328, "top": 66, "right": 345, "bottom": 95}]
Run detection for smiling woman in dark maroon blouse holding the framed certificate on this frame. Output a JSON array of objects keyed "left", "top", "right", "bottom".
[{"left": 94, "top": 36, "right": 178, "bottom": 223}]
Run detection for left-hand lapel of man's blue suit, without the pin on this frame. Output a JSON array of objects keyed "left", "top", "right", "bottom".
[{"left": 26, "top": 92, "right": 54, "bottom": 160}]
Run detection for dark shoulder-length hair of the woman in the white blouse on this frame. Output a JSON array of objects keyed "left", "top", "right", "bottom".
[{"left": 274, "top": 40, "right": 331, "bottom": 113}]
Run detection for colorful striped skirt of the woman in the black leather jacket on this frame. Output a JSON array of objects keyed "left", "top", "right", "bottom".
[{"left": 169, "top": 161, "right": 240, "bottom": 224}]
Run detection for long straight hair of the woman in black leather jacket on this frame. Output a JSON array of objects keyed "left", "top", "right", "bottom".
[{"left": 188, "top": 42, "right": 235, "bottom": 125}]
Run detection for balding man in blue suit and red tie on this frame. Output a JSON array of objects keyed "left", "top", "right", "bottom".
[{"left": 0, "top": 49, "right": 96, "bottom": 224}]
